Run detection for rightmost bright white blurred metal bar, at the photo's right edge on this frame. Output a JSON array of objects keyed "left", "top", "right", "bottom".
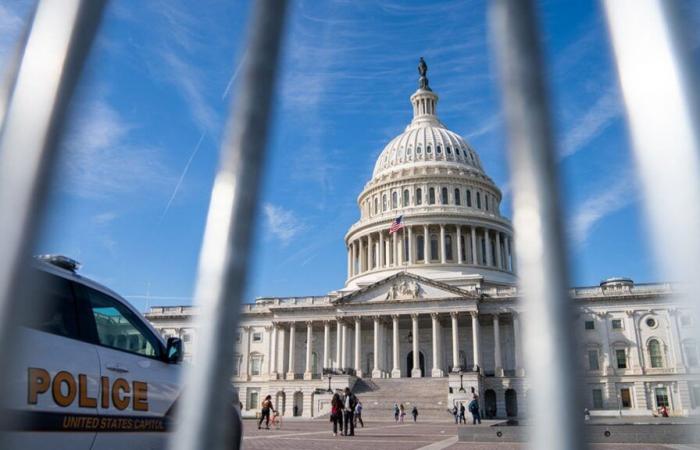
[{"left": 603, "top": 0, "right": 700, "bottom": 390}]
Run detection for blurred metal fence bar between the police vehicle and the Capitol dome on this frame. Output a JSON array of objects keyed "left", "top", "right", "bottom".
[{"left": 171, "top": 0, "right": 286, "bottom": 450}]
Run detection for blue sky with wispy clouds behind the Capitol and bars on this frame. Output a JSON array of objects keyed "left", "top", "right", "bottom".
[{"left": 0, "top": 0, "right": 700, "bottom": 309}]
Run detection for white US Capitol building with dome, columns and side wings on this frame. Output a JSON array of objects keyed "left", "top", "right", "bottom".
[{"left": 146, "top": 58, "right": 700, "bottom": 419}]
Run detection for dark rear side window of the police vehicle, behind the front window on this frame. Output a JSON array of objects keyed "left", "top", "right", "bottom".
[{"left": 21, "top": 271, "right": 78, "bottom": 339}]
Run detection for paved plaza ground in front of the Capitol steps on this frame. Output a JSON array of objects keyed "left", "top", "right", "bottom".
[{"left": 243, "top": 419, "right": 700, "bottom": 450}]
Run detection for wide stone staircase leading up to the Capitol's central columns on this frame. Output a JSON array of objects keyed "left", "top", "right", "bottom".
[{"left": 353, "top": 377, "right": 452, "bottom": 422}]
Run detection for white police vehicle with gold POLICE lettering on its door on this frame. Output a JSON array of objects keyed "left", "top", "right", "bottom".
[{"left": 2, "top": 255, "right": 240, "bottom": 450}]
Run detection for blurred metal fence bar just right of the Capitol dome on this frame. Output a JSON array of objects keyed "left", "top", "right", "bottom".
[{"left": 491, "top": 0, "right": 586, "bottom": 450}]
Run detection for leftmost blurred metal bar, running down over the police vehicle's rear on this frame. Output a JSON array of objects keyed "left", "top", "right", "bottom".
[{"left": 0, "top": 0, "right": 106, "bottom": 408}]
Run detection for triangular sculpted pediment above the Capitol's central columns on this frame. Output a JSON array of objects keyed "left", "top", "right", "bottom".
[{"left": 335, "top": 272, "right": 476, "bottom": 304}]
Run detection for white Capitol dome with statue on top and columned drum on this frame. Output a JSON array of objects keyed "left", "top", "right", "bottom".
[{"left": 345, "top": 58, "right": 516, "bottom": 290}]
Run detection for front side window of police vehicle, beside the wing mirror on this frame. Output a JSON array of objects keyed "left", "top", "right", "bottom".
[{"left": 87, "top": 289, "right": 159, "bottom": 357}]
